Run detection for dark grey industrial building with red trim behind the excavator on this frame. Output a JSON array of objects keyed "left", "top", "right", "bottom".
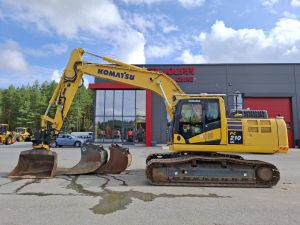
[{"left": 89, "top": 64, "right": 300, "bottom": 147}]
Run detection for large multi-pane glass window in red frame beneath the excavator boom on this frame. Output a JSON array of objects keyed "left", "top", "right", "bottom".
[{"left": 95, "top": 90, "right": 146, "bottom": 144}]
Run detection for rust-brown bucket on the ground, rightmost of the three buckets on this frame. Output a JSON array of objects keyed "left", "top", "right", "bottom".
[{"left": 93, "top": 144, "right": 132, "bottom": 174}]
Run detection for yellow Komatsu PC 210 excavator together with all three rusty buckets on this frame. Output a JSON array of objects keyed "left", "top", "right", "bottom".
[{"left": 10, "top": 48, "right": 288, "bottom": 187}]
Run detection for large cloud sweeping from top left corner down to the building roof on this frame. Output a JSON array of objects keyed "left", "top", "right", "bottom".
[{"left": 1, "top": 0, "right": 145, "bottom": 63}]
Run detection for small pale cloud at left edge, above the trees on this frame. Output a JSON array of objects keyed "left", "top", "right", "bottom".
[{"left": 0, "top": 40, "right": 28, "bottom": 72}]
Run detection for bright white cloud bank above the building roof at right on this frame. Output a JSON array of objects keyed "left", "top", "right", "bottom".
[{"left": 178, "top": 18, "right": 300, "bottom": 63}]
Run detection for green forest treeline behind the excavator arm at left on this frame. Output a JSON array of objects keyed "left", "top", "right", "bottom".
[{"left": 0, "top": 81, "right": 94, "bottom": 132}]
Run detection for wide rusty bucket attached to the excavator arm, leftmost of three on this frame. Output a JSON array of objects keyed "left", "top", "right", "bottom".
[{"left": 9, "top": 149, "right": 57, "bottom": 178}]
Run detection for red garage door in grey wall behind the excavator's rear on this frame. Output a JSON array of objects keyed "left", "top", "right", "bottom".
[{"left": 244, "top": 98, "right": 294, "bottom": 147}]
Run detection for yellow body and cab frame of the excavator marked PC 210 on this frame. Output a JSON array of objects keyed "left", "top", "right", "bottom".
[{"left": 170, "top": 96, "right": 289, "bottom": 153}]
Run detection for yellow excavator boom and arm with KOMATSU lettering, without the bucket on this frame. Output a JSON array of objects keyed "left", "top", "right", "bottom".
[{"left": 34, "top": 48, "right": 184, "bottom": 148}]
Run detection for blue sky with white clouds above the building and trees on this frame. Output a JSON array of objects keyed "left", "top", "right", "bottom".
[{"left": 0, "top": 0, "right": 300, "bottom": 88}]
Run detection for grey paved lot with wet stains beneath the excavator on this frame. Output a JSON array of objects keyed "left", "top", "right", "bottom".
[{"left": 0, "top": 143, "right": 300, "bottom": 225}]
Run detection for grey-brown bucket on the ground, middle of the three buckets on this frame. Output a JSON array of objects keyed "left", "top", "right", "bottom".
[{"left": 63, "top": 143, "right": 108, "bottom": 175}]
